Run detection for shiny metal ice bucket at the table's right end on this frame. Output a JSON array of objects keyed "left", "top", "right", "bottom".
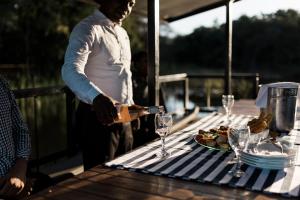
[{"left": 267, "top": 87, "right": 298, "bottom": 133}]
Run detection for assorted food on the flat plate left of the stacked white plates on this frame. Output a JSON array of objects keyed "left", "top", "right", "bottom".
[{"left": 195, "top": 126, "right": 230, "bottom": 151}]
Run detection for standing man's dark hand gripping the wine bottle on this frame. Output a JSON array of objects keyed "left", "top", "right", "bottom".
[{"left": 93, "top": 94, "right": 118, "bottom": 125}]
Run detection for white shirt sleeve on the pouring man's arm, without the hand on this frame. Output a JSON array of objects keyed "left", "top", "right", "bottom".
[{"left": 61, "top": 23, "right": 102, "bottom": 104}]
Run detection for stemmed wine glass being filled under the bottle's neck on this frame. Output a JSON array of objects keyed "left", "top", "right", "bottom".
[{"left": 155, "top": 113, "right": 173, "bottom": 158}]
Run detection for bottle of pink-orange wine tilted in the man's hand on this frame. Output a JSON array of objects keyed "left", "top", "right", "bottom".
[{"left": 114, "top": 104, "right": 165, "bottom": 123}]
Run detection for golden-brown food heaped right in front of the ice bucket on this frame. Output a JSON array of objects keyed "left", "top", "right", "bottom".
[{"left": 247, "top": 112, "right": 272, "bottom": 133}]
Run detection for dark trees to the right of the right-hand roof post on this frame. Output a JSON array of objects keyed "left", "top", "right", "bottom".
[{"left": 233, "top": 10, "right": 300, "bottom": 78}]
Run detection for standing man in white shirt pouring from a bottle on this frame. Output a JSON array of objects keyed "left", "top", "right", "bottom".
[{"left": 62, "top": 0, "right": 135, "bottom": 170}]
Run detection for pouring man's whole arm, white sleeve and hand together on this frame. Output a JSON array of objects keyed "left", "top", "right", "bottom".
[{"left": 62, "top": 23, "right": 117, "bottom": 124}]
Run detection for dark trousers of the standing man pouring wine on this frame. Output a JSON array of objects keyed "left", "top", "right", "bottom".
[{"left": 75, "top": 102, "right": 133, "bottom": 170}]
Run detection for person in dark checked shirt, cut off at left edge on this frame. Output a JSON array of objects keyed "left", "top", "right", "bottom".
[{"left": 0, "top": 76, "right": 30, "bottom": 198}]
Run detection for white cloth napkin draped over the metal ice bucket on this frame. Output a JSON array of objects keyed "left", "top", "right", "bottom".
[{"left": 255, "top": 82, "right": 300, "bottom": 108}]
